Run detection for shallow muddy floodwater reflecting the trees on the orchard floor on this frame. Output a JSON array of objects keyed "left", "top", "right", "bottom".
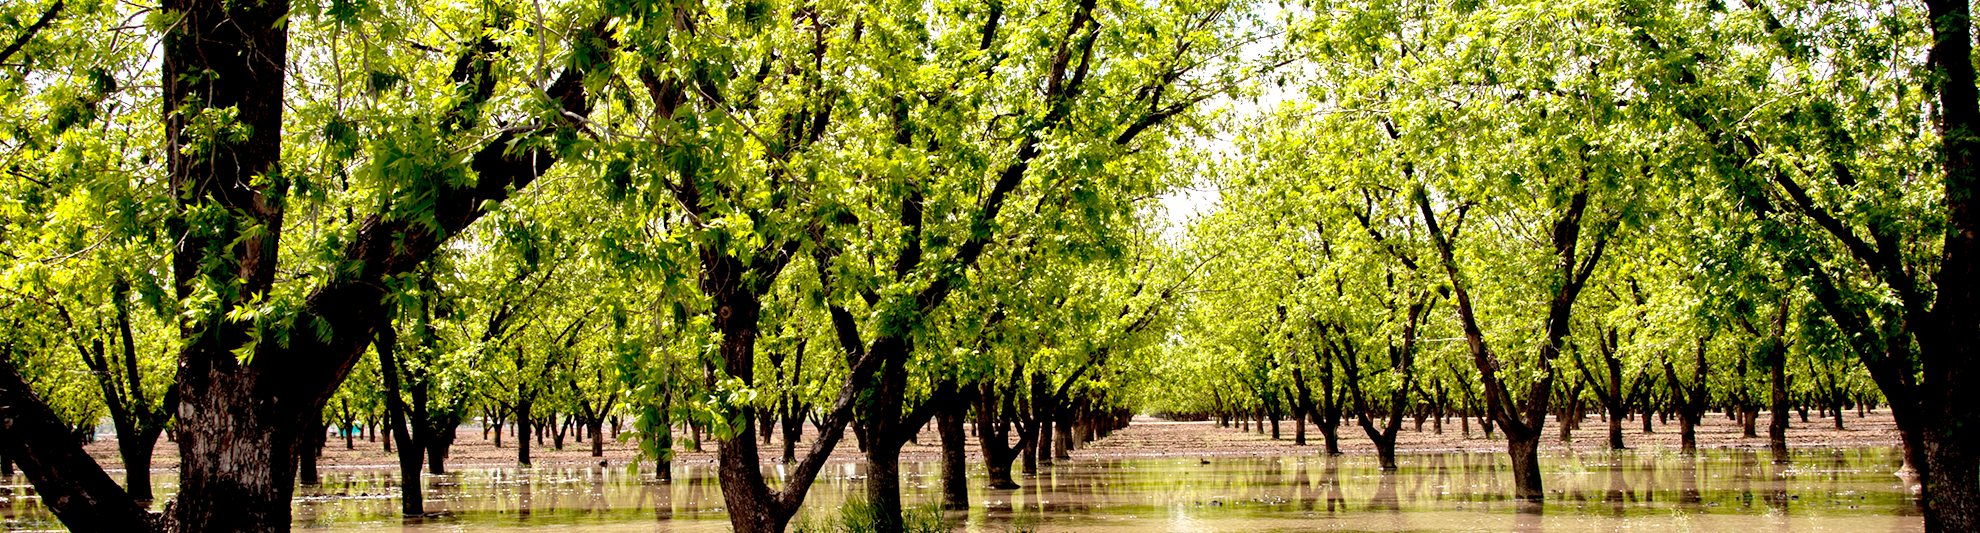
[{"left": 0, "top": 448, "right": 1923, "bottom": 533}]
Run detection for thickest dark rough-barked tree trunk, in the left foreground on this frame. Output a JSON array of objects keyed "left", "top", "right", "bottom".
[{"left": 159, "top": 0, "right": 293, "bottom": 523}]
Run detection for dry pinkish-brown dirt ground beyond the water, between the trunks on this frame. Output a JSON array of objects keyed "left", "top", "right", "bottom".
[{"left": 85, "top": 410, "right": 1899, "bottom": 472}]
